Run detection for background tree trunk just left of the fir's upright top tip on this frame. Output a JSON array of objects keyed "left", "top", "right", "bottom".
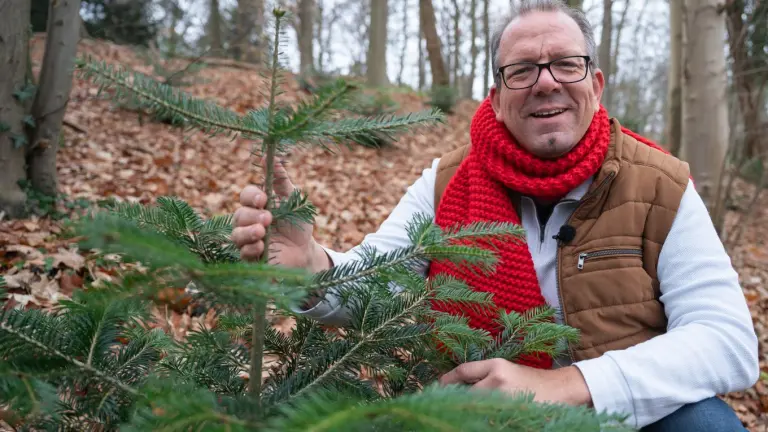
[{"left": 233, "top": 0, "right": 264, "bottom": 63}]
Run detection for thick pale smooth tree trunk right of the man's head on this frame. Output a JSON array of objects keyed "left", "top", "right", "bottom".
[{"left": 683, "top": 0, "right": 729, "bottom": 205}]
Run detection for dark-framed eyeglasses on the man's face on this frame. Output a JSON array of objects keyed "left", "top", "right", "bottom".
[{"left": 496, "top": 56, "right": 590, "bottom": 90}]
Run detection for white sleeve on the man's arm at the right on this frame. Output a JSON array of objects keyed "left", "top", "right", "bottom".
[{"left": 575, "top": 181, "right": 759, "bottom": 428}]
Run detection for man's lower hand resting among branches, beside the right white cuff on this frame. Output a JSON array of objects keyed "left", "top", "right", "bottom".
[{"left": 439, "top": 359, "right": 592, "bottom": 405}]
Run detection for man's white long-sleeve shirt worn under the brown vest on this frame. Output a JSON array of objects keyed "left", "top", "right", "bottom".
[{"left": 296, "top": 159, "right": 759, "bottom": 428}]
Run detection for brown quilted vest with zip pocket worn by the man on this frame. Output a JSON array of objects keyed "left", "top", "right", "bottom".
[{"left": 435, "top": 120, "right": 689, "bottom": 361}]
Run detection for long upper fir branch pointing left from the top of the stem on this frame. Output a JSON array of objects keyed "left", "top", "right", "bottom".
[{"left": 75, "top": 58, "right": 267, "bottom": 138}]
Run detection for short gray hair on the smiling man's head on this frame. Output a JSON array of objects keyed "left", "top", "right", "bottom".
[{"left": 491, "top": 0, "right": 598, "bottom": 88}]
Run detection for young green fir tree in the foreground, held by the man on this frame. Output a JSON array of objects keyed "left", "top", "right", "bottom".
[{"left": 0, "top": 10, "right": 623, "bottom": 431}]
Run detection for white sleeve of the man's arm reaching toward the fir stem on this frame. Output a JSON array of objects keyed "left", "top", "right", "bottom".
[{"left": 295, "top": 159, "right": 440, "bottom": 325}]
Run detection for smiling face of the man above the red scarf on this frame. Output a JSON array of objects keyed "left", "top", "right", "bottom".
[{"left": 491, "top": 12, "right": 604, "bottom": 158}]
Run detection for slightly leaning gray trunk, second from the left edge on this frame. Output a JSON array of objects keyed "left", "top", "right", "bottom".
[{"left": 27, "top": 0, "right": 80, "bottom": 196}]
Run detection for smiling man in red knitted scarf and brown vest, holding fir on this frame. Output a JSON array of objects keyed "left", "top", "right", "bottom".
[{"left": 233, "top": 0, "right": 759, "bottom": 431}]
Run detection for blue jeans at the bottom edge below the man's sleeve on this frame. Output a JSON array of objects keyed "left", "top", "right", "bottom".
[{"left": 641, "top": 397, "right": 746, "bottom": 432}]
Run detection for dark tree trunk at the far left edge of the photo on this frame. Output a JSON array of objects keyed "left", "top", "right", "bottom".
[{"left": 0, "top": 0, "right": 30, "bottom": 218}]
